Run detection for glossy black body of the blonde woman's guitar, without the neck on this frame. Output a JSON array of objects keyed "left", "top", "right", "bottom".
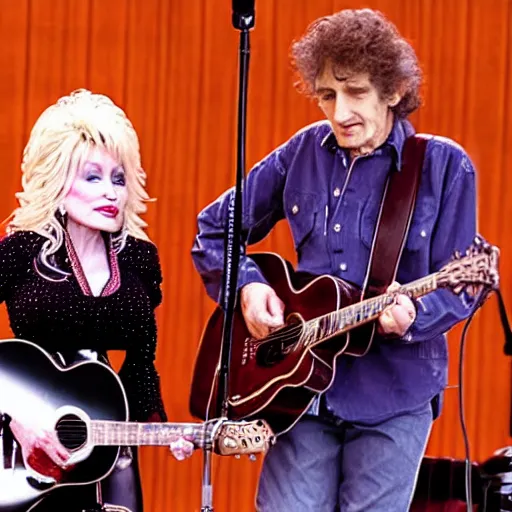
[{"left": 0, "top": 340, "right": 128, "bottom": 512}]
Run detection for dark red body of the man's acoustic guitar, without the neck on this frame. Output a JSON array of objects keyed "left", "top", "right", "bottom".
[{"left": 190, "top": 253, "right": 375, "bottom": 433}]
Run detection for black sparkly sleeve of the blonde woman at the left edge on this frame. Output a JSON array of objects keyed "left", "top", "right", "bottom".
[{"left": 0, "top": 231, "right": 42, "bottom": 302}]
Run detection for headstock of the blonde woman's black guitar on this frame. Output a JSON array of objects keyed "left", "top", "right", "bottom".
[{"left": 214, "top": 420, "right": 275, "bottom": 455}]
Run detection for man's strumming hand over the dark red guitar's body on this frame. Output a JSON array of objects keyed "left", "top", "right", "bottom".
[{"left": 240, "top": 283, "right": 284, "bottom": 339}]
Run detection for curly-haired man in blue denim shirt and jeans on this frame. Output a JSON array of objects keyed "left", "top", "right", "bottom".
[{"left": 192, "top": 9, "right": 476, "bottom": 512}]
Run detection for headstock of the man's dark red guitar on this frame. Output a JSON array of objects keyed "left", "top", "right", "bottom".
[{"left": 437, "top": 237, "right": 500, "bottom": 293}]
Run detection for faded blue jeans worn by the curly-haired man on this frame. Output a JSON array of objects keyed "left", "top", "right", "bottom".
[{"left": 256, "top": 403, "right": 432, "bottom": 512}]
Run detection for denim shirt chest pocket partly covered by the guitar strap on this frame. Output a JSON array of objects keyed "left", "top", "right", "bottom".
[{"left": 359, "top": 197, "right": 436, "bottom": 252}]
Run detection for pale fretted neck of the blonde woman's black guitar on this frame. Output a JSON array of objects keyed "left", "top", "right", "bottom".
[{"left": 90, "top": 420, "right": 212, "bottom": 448}]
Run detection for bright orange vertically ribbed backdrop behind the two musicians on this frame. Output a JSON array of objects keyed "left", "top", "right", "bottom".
[{"left": 0, "top": 0, "right": 512, "bottom": 512}]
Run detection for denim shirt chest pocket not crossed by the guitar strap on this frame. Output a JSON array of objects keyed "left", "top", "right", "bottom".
[{"left": 284, "top": 190, "right": 320, "bottom": 251}]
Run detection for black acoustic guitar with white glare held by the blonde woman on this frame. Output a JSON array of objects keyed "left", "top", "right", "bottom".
[{"left": 0, "top": 340, "right": 274, "bottom": 512}]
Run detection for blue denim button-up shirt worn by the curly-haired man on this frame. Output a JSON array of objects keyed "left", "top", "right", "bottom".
[{"left": 192, "top": 120, "right": 476, "bottom": 422}]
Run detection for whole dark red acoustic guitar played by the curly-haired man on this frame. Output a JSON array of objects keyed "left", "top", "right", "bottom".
[{"left": 190, "top": 240, "right": 499, "bottom": 434}]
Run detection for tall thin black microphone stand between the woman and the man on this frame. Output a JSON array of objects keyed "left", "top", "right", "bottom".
[{"left": 201, "top": 5, "right": 254, "bottom": 512}]
